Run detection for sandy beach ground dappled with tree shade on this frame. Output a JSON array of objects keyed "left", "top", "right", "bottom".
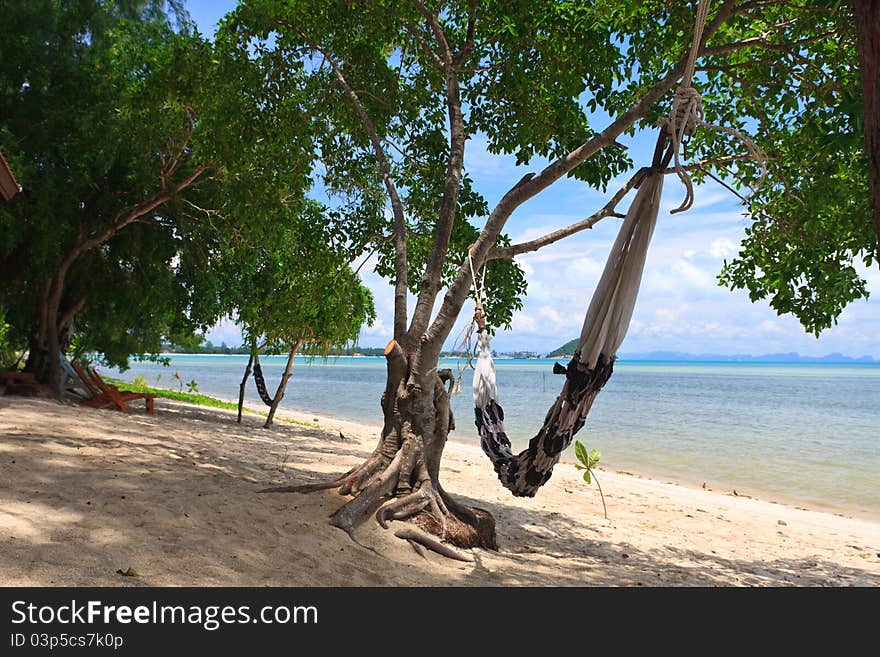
[{"left": 0, "top": 397, "right": 880, "bottom": 586}]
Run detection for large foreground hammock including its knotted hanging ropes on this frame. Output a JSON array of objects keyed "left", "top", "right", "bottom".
[{"left": 471, "top": 0, "right": 766, "bottom": 497}]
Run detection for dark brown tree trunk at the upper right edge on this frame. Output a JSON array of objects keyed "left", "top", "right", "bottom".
[{"left": 853, "top": 0, "right": 880, "bottom": 266}]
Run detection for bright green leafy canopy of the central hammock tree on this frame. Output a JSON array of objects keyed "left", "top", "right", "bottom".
[{"left": 221, "top": 0, "right": 871, "bottom": 332}]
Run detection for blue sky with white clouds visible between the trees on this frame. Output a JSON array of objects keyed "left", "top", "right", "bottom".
[{"left": 187, "top": 0, "right": 880, "bottom": 358}]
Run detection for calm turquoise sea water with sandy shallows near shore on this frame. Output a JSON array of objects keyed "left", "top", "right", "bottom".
[{"left": 111, "top": 355, "right": 880, "bottom": 513}]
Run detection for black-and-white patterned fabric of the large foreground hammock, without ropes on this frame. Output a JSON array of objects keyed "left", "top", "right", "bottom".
[{"left": 473, "top": 173, "right": 663, "bottom": 497}]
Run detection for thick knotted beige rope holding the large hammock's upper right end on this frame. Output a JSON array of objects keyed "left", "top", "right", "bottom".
[{"left": 666, "top": 0, "right": 767, "bottom": 214}]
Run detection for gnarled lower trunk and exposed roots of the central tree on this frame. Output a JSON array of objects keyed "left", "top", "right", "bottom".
[{"left": 264, "top": 340, "right": 497, "bottom": 561}]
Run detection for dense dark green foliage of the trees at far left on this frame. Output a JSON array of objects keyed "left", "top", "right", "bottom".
[{"left": 0, "top": 0, "right": 311, "bottom": 365}]
